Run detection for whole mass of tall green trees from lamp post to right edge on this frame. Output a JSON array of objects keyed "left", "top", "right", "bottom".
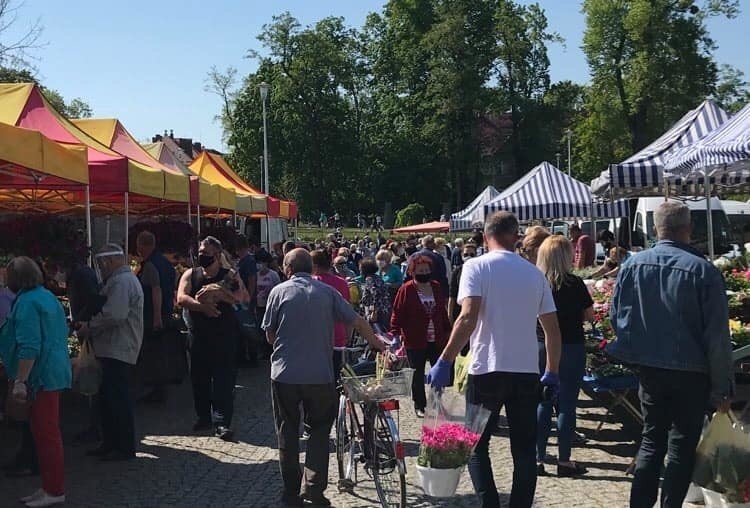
[{"left": 219, "top": 0, "right": 747, "bottom": 221}]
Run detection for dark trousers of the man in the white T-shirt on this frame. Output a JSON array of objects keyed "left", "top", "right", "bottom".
[{"left": 466, "top": 372, "right": 539, "bottom": 508}]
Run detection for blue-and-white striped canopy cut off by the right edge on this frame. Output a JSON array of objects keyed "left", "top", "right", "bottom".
[{"left": 664, "top": 104, "right": 750, "bottom": 178}]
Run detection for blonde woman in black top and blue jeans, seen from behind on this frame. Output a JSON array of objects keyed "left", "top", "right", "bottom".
[{"left": 537, "top": 235, "right": 594, "bottom": 477}]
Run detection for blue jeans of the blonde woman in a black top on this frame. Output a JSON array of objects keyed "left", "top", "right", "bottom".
[{"left": 536, "top": 344, "right": 586, "bottom": 462}]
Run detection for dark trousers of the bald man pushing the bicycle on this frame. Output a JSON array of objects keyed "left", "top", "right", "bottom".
[{"left": 271, "top": 381, "right": 337, "bottom": 496}]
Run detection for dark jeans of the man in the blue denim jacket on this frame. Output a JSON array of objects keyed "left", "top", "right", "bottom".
[{"left": 630, "top": 367, "right": 710, "bottom": 508}]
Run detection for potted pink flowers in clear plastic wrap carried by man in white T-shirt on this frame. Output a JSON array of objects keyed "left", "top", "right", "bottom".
[{"left": 417, "top": 390, "right": 490, "bottom": 497}]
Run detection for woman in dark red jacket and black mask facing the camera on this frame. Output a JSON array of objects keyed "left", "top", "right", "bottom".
[{"left": 391, "top": 256, "right": 451, "bottom": 418}]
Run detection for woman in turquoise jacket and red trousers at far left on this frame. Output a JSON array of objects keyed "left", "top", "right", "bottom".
[{"left": 0, "top": 257, "right": 71, "bottom": 508}]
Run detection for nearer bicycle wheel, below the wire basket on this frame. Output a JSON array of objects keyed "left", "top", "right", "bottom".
[{"left": 371, "top": 410, "right": 406, "bottom": 508}]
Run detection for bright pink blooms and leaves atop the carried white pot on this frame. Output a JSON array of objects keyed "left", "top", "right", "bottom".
[{"left": 417, "top": 423, "right": 481, "bottom": 469}]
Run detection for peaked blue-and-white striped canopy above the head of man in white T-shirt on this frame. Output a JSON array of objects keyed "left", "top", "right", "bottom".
[{"left": 484, "top": 162, "right": 628, "bottom": 221}]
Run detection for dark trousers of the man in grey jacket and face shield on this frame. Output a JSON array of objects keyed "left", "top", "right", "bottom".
[{"left": 99, "top": 358, "right": 135, "bottom": 454}]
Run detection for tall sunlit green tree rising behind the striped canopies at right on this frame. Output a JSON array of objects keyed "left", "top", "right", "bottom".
[{"left": 575, "top": 0, "right": 739, "bottom": 181}]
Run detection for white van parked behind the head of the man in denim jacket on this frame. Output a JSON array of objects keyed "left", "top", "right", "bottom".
[{"left": 632, "top": 197, "right": 732, "bottom": 254}]
